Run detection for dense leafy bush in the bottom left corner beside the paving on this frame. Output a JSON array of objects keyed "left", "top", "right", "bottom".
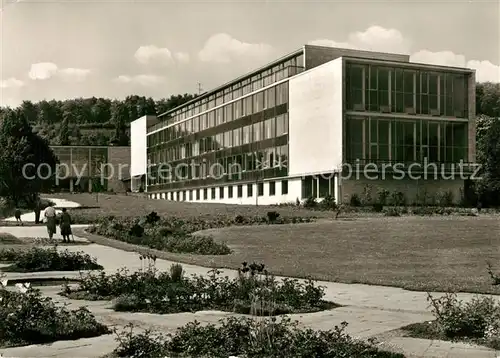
[{"left": 0, "top": 284, "right": 111, "bottom": 346}]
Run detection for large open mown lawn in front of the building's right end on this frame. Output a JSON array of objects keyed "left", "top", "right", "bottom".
[{"left": 77, "top": 216, "right": 500, "bottom": 294}]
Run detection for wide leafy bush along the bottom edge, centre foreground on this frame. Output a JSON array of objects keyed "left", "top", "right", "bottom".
[{"left": 114, "top": 317, "right": 404, "bottom": 358}]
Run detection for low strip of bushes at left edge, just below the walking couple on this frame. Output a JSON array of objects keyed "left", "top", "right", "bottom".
[{"left": 0, "top": 245, "right": 103, "bottom": 272}]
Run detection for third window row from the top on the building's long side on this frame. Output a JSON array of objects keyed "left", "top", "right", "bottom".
[{"left": 148, "top": 113, "right": 288, "bottom": 164}]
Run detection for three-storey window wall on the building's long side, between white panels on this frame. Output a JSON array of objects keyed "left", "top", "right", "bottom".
[{"left": 148, "top": 82, "right": 288, "bottom": 190}]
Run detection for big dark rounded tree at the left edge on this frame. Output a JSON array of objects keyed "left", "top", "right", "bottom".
[{"left": 0, "top": 109, "right": 57, "bottom": 207}]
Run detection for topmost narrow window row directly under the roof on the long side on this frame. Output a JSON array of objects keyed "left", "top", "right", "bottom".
[{"left": 148, "top": 54, "right": 304, "bottom": 131}]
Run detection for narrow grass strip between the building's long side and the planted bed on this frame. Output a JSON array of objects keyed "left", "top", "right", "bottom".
[{"left": 46, "top": 193, "right": 335, "bottom": 219}]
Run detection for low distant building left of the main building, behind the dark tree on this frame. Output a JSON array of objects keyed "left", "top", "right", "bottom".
[{"left": 51, "top": 146, "right": 131, "bottom": 192}]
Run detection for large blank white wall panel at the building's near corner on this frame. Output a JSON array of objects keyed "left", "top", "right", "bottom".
[{"left": 288, "top": 58, "right": 343, "bottom": 177}]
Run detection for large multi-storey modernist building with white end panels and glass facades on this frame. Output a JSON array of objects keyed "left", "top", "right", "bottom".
[{"left": 131, "top": 45, "right": 475, "bottom": 204}]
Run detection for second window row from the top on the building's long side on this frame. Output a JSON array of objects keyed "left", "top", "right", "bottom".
[{"left": 148, "top": 82, "right": 288, "bottom": 147}]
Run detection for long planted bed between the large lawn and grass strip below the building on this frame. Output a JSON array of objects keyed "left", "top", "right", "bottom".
[{"left": 84, "top": 212, "right": 313, "bottom": 255}]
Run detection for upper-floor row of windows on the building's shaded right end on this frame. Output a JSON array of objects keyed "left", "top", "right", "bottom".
[{"left": 347, "top": 64, "right": 468, "bottom": 118}]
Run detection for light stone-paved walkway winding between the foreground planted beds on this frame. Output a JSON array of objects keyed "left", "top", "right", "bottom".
[{"left": 0, "top": 200, "right": 500, "bottom": 358}]
